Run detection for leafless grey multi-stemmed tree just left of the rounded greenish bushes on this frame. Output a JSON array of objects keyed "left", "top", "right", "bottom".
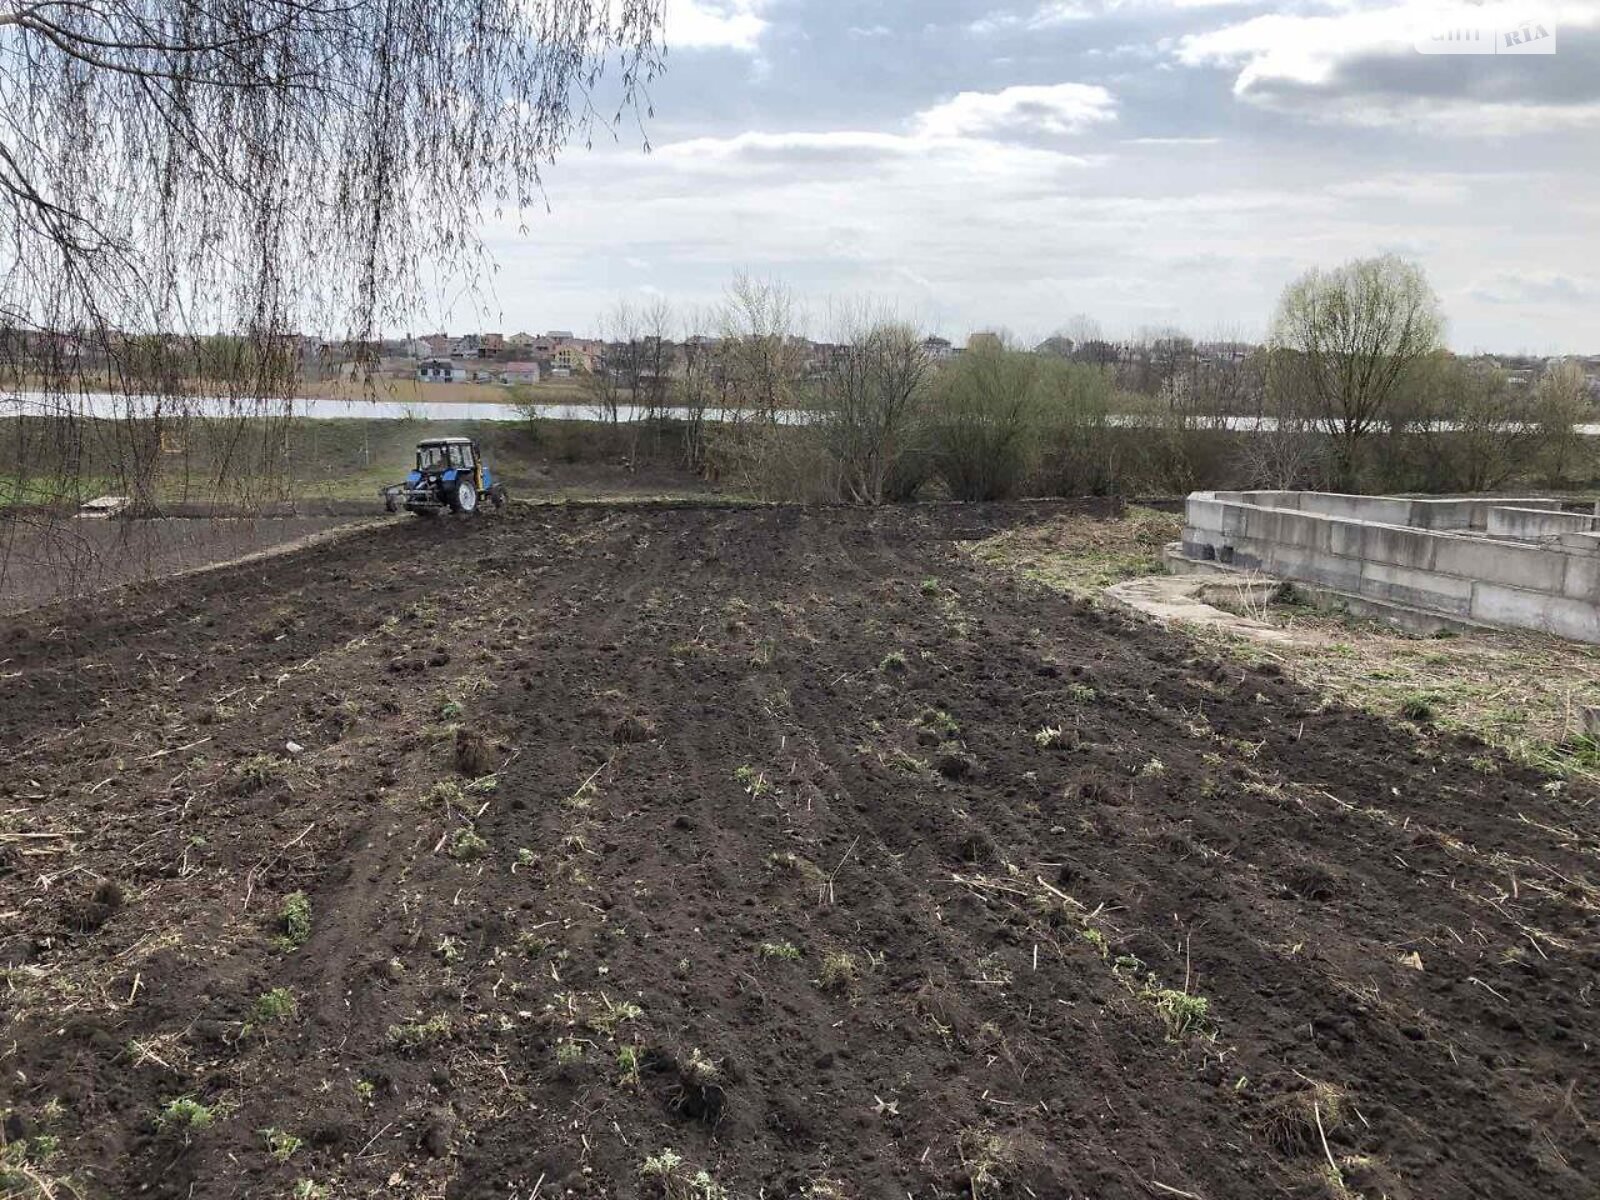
[{"left": 821, "top": 306, "right": 931, "bottom": 504}]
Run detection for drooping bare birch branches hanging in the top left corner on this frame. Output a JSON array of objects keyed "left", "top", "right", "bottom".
[{"left": 0, "top": 0, "right": 662, "bottom": 512}]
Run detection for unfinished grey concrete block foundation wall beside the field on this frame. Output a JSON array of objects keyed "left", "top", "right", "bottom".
[{"left": 1182, "top": 491, "right": 1600, "bottom": 643}]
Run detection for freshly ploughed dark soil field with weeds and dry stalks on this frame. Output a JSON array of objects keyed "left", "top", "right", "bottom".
[{"left": 0, "top": 506, "right": 1600, "bottom": 1200}]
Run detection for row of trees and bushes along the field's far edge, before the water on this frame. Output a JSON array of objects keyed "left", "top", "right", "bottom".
[{"left": 563, "top": 256, "right": 1594, "bottom": 504}]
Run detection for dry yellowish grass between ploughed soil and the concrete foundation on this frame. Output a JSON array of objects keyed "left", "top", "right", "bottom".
[{"left": 973, "top": 507, "right": 1600, "bottom": 782}]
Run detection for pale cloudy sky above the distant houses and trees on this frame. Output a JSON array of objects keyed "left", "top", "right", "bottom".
[{"left": 454, "top": 0, "right": 1600, "bottom": 354}]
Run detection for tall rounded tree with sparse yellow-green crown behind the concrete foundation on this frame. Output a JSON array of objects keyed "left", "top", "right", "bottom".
[{"left": 1270, "top": 254, "right": 1443, "bottom": 488}]
